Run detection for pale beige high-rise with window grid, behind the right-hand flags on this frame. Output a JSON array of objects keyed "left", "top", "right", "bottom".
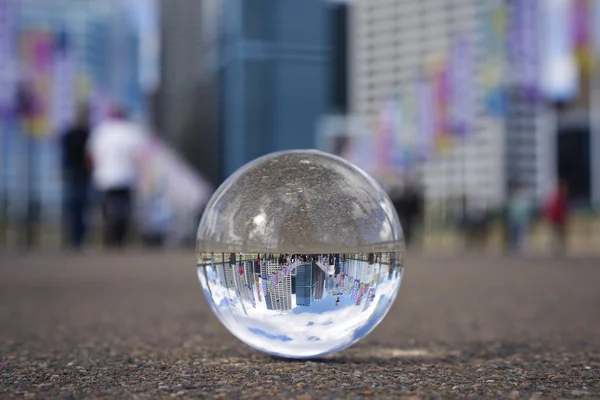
[{"left": 351, "top": 0, "right": 520, "bottom": 211}]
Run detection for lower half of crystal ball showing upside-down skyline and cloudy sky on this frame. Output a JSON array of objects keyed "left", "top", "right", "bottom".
[{"left": 198, "top": 253, "right": 403, "bottom": 357}]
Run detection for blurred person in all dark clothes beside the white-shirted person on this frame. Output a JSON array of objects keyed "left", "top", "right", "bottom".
[{"left": 61, "top": 106, "right": 91, "bottom": 249}]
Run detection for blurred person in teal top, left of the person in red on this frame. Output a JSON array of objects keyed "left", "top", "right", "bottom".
[{"left": 507, "top": 182, "right": 533, "bottom": 253}]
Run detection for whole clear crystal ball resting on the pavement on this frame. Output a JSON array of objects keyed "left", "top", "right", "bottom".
[{"left": 197, "top": 150, "right": 404, "bottom": 358}]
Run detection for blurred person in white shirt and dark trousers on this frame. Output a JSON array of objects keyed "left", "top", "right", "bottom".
[{"left": 87, "top": 108, "right": 146, "bottom": 247}]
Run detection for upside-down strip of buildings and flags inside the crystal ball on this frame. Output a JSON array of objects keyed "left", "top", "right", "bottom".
[{"left": 199, "top": 253, "right": 399, "bottom": 313}]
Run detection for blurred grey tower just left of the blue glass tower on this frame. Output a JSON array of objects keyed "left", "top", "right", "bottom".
[{"left": 153, "top": 0, "right": 221, "bottom": 185}]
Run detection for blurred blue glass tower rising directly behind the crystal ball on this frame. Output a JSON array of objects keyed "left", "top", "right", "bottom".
[{"left": 203, "top": 0, "right": 345, "bottom": 177}]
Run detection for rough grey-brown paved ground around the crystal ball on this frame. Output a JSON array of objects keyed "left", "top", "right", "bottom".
[{"left": 0, "top": 252, "right": 600, "bottom": 399}]
